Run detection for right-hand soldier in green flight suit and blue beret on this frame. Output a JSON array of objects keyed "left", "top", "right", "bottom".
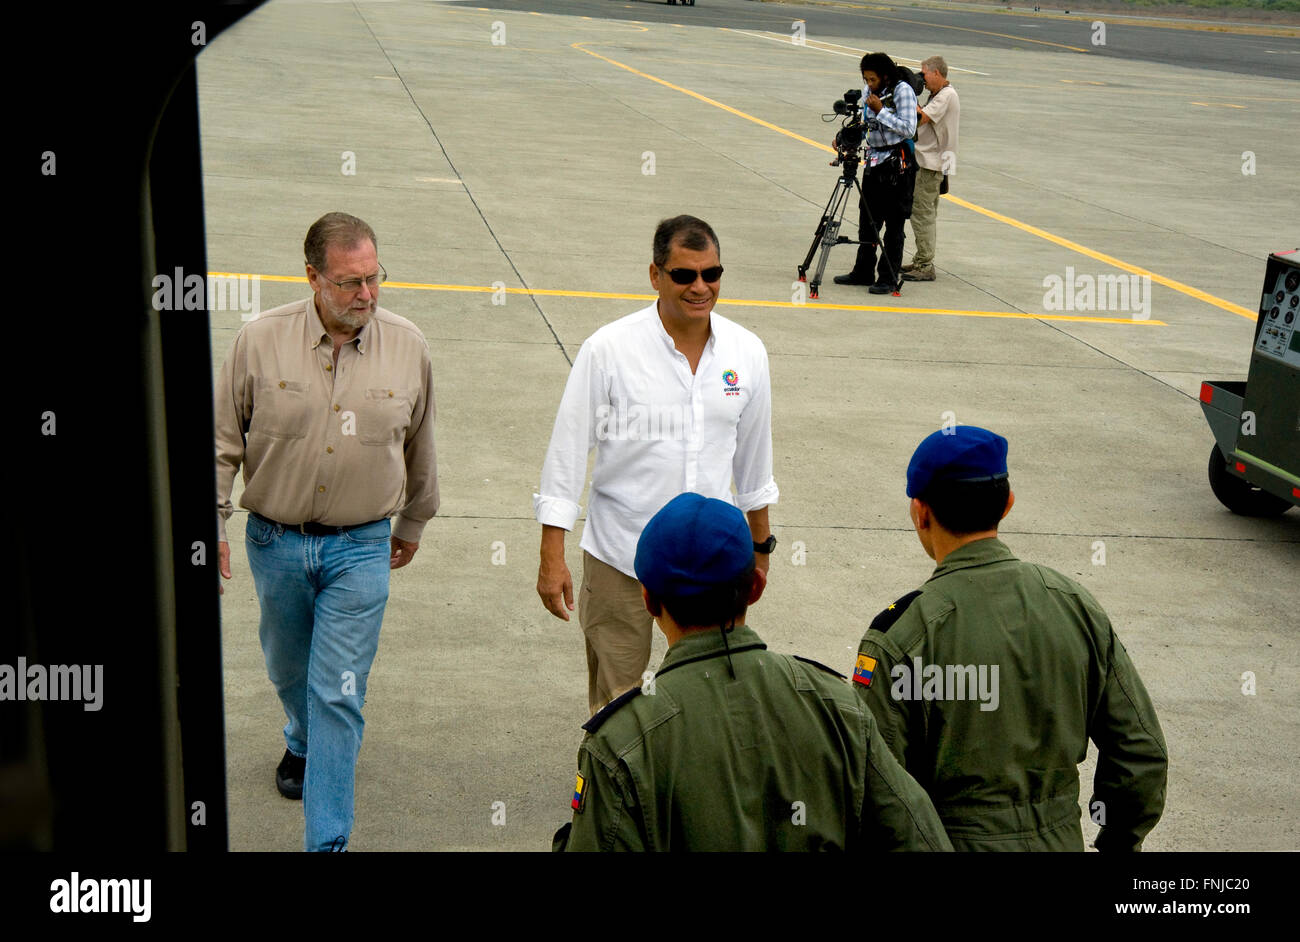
[{"left": 853, "top": 426, "right": 1169, "bottom": 851}]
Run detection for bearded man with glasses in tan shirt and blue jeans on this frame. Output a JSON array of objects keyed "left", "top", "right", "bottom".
[{"left": 216, "top": 213, "right": 438, "bottom": 851}]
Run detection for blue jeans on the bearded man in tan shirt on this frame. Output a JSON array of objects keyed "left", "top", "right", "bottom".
[{"left": 246, "top": 513, "right": 390, "bottom": 851}]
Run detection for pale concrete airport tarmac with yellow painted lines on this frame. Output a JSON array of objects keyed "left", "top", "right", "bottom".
[{"left": 199, "top": 0, "right": 1300, "bottom": 851}]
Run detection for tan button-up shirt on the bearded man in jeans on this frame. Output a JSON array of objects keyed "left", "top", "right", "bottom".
[{"left": 216, "top": 298, "right": 438, "bottom": 543}]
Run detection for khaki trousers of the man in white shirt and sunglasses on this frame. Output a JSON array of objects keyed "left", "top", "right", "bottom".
[{"left": 577, "top": 550, "right": 654, "bottom": 715}]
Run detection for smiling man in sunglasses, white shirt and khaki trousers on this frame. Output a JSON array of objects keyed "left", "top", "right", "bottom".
[{"left": 533, "top": 216, "right": 777, "bottom": 713}]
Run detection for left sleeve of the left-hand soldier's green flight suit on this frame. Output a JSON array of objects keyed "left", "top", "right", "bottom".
[{"left": 553, "top": 735, "right": 650, "bottom": 851}]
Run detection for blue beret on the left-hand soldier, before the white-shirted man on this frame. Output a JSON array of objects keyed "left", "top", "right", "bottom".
[{"left": 633, "top": 494, "right": 754, "bottom": 599}]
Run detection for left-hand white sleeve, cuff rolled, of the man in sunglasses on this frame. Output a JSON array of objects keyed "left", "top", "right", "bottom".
[{"left": 533, "top": 340, "right": 608, "bottom": 530}]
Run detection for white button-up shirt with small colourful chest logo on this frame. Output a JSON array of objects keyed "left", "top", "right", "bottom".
[{"left": 533, "top": 303, "right": 779, "bottom": 578}]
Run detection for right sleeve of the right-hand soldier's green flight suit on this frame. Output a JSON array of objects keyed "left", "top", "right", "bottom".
[{"left": 1088, "top": 624, "right": 1169, "bottom": 851}]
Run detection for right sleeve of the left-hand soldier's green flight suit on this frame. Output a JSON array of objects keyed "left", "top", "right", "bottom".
[{"left": 862, "top": 712, "right": 953, "bottom": 851}]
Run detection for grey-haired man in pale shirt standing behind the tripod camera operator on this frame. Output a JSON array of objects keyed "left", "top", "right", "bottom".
[{"left": 902, "top": 56, "right": 961, "bottom": 281}]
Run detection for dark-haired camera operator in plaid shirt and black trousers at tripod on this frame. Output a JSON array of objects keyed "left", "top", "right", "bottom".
[{"left": 835, "top": 52, "right": 917, "bottom": 295}]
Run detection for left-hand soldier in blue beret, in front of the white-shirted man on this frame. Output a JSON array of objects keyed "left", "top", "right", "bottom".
[{"left": 553, "top": 494, "right": 952, "bottom": 851}]
